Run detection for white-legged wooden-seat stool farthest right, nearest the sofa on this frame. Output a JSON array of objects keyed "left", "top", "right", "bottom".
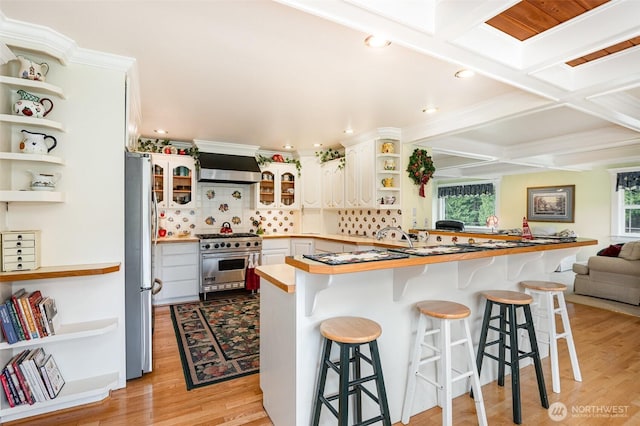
[{"left": 520, "top": 281, "right": 582, "bottom": 393}]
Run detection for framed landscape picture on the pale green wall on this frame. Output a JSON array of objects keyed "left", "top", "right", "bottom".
[{"left": 527, "top": 185, "right": 576, "bottom": 223}]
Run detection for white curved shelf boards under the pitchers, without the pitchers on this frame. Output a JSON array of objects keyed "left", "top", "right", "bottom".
[{"left": 0, "top": 76, "right": 65, "bottom": 202}]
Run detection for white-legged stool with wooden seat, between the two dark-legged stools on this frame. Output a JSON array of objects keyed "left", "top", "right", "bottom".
[{"left": 402, "top": 300, "right": 487, "bottom": 425}]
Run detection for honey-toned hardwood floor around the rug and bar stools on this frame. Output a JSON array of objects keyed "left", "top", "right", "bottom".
[{"left": 5, "top": 303, "right": 640, "bottom": 426}]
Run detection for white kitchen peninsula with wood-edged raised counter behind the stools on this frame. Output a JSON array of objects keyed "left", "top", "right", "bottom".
[{"left": 257, "top": 239, "right": 597, "bottom": 426}]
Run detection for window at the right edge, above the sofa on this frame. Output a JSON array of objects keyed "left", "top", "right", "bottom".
[{"left": 610, "top": 169, "right": 640, "bottom": 238}]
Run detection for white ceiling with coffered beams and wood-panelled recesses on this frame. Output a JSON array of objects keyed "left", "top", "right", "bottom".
[{"left": 0, "top": 0, "right": 640, "bottom": 178}]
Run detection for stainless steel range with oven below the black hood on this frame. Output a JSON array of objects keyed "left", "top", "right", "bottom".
[{"left": 196, "top": 233, "right": 262, "bottom": 300}]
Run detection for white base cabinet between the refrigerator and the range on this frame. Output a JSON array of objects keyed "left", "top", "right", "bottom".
[{"left": 152, "top": 242, "right": 200, "bottom": 305}]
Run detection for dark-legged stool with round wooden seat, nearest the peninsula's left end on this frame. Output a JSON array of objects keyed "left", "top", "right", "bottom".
[{"left": 312, "top": 317, "right": 391, "bottom": 426}]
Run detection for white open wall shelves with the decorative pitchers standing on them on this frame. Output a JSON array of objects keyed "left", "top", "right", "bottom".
[{"left": 0, "top": 56, "right": 65, "bottom": 202}]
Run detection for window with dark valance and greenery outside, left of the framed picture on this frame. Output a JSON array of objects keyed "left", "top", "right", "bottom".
[{"left": 438, "top": 183, "right": 496, "bottom": 228}]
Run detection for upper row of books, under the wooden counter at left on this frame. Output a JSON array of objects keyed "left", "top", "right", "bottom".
[{"left": 0, "top": 289, "right": 59, "bottom": 344}]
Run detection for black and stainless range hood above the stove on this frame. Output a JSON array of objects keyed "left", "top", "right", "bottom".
[{"left": 198, "top": 152, "right": 261, "bottom": 183}]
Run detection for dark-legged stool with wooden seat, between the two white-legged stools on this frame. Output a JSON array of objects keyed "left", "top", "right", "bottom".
[{"left": 477, "top": 290, "right": 549, "bottom": 424}]
